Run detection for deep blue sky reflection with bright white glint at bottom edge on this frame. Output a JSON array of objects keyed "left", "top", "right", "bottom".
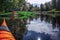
[{"left": 23, "top": 31, "right": 51, "bottom": 40}]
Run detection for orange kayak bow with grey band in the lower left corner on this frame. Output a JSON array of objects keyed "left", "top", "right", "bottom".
[{"left": 0, "top": 19, "right": 15, "bottom": 40}]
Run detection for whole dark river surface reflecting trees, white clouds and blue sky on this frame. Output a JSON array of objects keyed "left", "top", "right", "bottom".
[{"left": 0, "top": 14, "right": 60, "bottom": 40}]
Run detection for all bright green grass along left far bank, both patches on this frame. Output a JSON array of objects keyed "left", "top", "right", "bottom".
[{"left": 0, "top": 11, "right": 35, "bottom": 19}]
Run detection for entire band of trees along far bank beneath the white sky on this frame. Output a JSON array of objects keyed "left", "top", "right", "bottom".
[{"left": 0, "top": 0, "right": 60, "bottom": 12}]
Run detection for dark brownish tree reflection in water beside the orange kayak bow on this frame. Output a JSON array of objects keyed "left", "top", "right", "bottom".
[{"left": 0, "top": 17, "right": 27, "bottom": 40}]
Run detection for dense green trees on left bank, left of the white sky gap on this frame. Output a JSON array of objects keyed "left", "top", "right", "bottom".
[{"left": 0, "top": 0, "right": 25, "bottom": 12}]
